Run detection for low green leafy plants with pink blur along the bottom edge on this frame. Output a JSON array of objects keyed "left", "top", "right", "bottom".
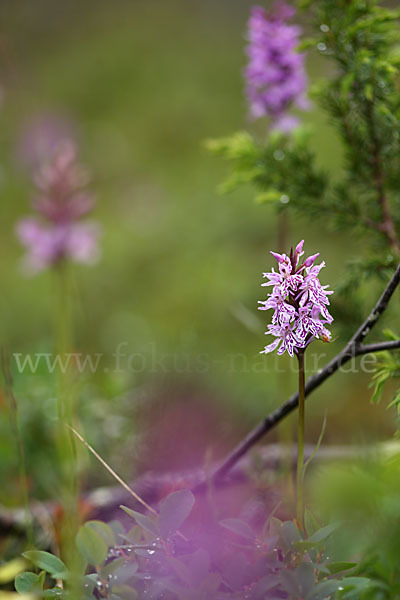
[{"left": 15, "top": 490, "right": 381, "bottom": 600}]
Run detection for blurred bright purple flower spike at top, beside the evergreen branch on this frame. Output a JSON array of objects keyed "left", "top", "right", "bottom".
[{"left": 244, "top": 2, "right": 309, "bottom": 132}]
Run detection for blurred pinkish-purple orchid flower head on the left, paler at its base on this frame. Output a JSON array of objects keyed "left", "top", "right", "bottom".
[{"left": 17, "top": 141, "right": 100, "bottom": 273}]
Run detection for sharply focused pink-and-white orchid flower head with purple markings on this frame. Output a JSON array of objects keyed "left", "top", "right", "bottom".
[{"left": 258, "top": 240, "right": 333, "bottom": 356}]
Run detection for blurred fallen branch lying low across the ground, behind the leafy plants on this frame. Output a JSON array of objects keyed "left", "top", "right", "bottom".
[{"left": 0, "top": 441, "right": 400, "bottom": 549}]
